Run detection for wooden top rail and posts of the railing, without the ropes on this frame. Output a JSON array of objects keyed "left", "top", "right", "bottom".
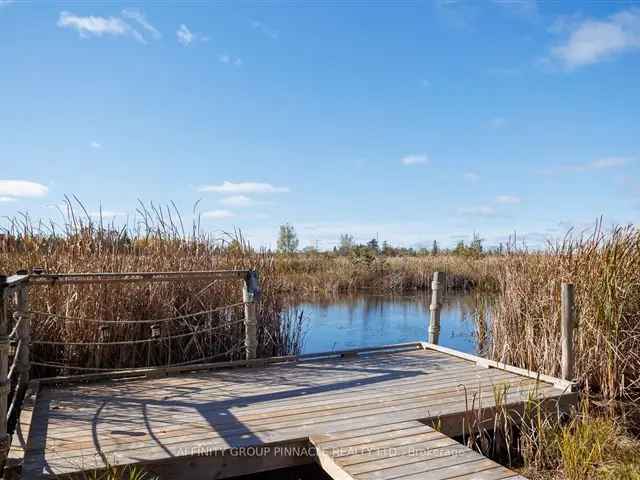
[{"left": 0, "top": 270, "right": 260, "bottom": 472}]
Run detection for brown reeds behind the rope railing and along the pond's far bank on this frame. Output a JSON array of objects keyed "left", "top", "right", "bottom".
[{"left": 0, "top": 197, "right": 495, "bottom": 376}]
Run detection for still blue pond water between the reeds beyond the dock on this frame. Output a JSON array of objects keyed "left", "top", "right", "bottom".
[{"left": 297, "top": 293, "right": 484, "bottom": 354}]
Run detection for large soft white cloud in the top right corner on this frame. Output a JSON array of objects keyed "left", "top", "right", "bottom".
[{"left": 550, "top": 8, "right": 640, "bottom": 70}]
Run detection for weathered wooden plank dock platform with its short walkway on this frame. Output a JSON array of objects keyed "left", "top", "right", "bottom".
[{"left": 10, "top": 343, "right": 576, "bottom": 480}]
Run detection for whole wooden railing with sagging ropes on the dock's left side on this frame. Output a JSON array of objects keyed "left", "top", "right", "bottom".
[{"left": 0, "top": 270, "right": 260, "bottom": 472}]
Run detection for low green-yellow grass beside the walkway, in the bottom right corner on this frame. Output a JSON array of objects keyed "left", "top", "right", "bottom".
[{"left": 461, "top": 385, "right": 640, "bottom": 480}]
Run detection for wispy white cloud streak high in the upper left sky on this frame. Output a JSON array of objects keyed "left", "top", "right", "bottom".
[{"left": 58, "top": 10, "right": 160, "bottom": 44}]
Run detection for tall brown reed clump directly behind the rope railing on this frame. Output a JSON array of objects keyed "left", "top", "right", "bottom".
[{"left": 0, "top": 199, "right": 302, "bottom": 376}]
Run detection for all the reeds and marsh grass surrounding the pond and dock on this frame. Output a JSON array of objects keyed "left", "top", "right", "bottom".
[{"left": 0, "top": 201, "right": 640, "bottom": 480}]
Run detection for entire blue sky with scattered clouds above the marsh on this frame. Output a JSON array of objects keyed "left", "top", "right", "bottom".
[{"left": 0, "top": 0, "right": 640, "bottom": 248}]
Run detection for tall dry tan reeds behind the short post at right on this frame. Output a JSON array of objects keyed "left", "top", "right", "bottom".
[{"left": 492, "top": 221, "right": 640, "bottom": 416}]
